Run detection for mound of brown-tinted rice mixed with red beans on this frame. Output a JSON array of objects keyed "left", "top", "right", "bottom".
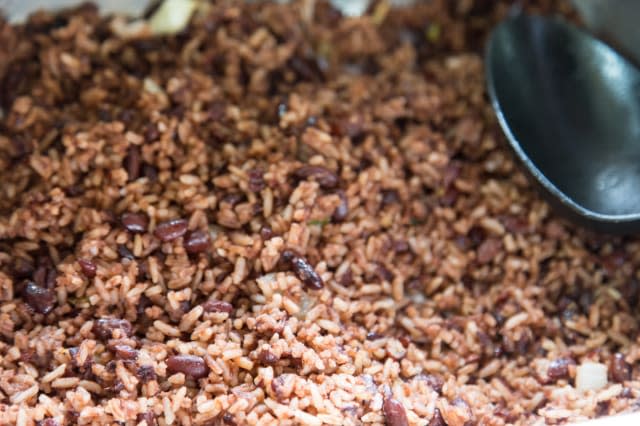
[{"left": 0, "top": 0, "right": 640, "bottom": 426}]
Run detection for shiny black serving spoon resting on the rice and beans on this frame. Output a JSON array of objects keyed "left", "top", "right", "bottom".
[{"left": 486, "top": 15, "right": 640, "bottom": 233}]
